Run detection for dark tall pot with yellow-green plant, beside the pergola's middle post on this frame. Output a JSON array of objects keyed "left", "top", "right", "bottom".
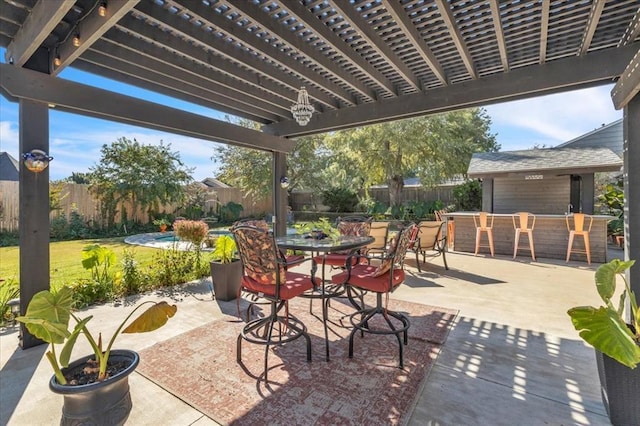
[{"left": 210, "top": 235, "right": 242, "bottom": 301}]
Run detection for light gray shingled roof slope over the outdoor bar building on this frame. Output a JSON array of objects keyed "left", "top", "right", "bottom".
[{"left": 467, "top": 148, "right": 622, "bottom": 178}]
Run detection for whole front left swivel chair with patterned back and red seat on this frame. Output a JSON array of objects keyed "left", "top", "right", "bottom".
[{"left": 231, "top": 224, "right": 313, "bottom": 381}]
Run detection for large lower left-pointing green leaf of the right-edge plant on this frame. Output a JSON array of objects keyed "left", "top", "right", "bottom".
[{"left": 567, "top": 306, "right": 640, "bottom": 368}]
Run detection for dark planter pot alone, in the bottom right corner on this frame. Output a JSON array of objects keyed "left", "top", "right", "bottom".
[{"left": 596, "top": 351, "right": 640, "bottom": 426}]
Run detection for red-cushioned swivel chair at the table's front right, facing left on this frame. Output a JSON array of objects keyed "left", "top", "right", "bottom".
[{"left": 332, "top": 224, "right": 415, "bottom": 368}]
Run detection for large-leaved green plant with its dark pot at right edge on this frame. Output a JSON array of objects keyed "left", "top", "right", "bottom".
[{"left": 567, "top": 259, "right": 640, "bottom": 426}]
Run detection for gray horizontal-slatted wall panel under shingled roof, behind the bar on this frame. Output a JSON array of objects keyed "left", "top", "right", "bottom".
[{"left": 493, "top": 175, "right": 570, "bottom": 214}]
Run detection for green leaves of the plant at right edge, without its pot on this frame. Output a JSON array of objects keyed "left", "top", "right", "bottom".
[{"left": 567, "top": 259, "right": 640, "bottom": 368}]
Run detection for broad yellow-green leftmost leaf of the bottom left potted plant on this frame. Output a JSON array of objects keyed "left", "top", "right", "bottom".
[{"left": 16, "top": 287, "right": 73, "bottom": 343}]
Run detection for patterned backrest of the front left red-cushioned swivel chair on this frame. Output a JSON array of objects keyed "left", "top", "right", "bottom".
[{"left": 231, "top": 224, "right": 286, "bottom": 285}]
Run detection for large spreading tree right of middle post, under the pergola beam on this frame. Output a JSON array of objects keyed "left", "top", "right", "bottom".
[{"left": 329, "top": 108, "right": 500, "bottom": 206}]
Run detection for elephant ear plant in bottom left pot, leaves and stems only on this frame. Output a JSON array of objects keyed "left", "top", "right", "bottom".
[{"left": 16, "top": 287, "right": 177, "bottom": 385}]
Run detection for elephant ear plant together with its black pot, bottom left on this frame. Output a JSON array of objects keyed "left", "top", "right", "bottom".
[{"left": 16, "top": 287, "right": 177, "bottom": 425}]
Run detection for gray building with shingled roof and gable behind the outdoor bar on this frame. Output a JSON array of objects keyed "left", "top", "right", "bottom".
[{"left": 468, "top": 120, "right": 622, "bottom": 214}]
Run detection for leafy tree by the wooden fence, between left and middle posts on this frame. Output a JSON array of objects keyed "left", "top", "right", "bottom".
[{"left": 89, "top": 137, "right": 193, "bottom": 225}]
